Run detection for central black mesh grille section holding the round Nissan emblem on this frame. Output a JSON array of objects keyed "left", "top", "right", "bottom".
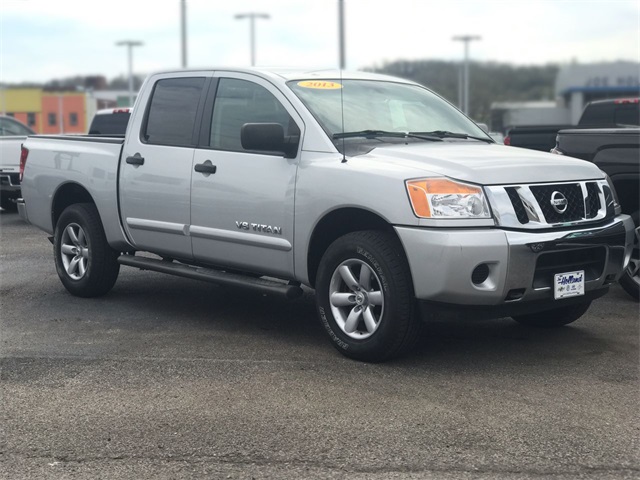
[{"left": 530, "top": 183, "right": 584, "bottom": 223}]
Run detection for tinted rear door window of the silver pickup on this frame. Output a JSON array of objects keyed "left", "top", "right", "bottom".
[{"left": 143, "top": 78, "right": 205, "bottom": 146}]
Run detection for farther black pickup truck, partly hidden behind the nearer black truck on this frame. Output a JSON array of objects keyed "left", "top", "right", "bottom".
[{"left": 504, "top": 98, "right": 640, "bottom": 152}]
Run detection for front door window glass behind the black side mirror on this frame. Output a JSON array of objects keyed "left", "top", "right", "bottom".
[{"left": 209, "top": 78, "right": 300, "bottom": 151}]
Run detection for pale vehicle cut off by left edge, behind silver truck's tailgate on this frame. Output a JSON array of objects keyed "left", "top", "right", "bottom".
[{"left": 0, "top": 115, "right": 35, "bottom": 210}]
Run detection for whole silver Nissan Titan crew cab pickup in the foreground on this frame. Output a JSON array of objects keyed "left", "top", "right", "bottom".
[{"left": 18, "top": 69, "right": 633, "bottom": 361}]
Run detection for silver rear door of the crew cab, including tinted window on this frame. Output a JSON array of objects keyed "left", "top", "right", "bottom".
[{"left": 119, "top": 72, "right": 211, "bottom": 260}]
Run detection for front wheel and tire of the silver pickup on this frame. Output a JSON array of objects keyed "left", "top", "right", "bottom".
[{"left": 316, "top": 231, "right": 422, "bottom": 362}]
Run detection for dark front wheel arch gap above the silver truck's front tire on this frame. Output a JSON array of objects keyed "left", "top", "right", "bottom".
[{"left": 307, "top": 207, "right": 402, "bottom": 288}]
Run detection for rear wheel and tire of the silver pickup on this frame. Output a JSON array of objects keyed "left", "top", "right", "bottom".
[{"left": 53, "top": 203, "right": 120, "bottom": 297}]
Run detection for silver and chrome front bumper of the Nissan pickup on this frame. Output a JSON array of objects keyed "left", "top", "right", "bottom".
[{"left": 396, "top": 215, "right": 634, "bottom": 309}]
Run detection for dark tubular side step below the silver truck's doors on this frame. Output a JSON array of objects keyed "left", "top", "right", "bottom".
[{"left": 118, "top": 255, "right": 303, "bottom": 299}]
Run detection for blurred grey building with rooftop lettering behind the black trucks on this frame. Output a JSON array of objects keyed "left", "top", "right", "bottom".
[{"left": 491, "top": 62, "right": 640, "bottom": 132}]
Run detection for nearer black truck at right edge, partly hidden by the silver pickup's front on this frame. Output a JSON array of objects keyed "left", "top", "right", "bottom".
[{"left": 552, "top": 128, "right": 640, "bottom": 300}]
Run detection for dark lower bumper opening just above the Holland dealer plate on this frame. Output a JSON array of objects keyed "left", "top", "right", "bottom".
[{"left": 533, "top": 247, "right": 607, "bottom": 288}]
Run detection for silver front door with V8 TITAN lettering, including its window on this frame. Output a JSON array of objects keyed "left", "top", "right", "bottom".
[{"left": 190, "top": 72, "right": 303, "bottom": 277}]
